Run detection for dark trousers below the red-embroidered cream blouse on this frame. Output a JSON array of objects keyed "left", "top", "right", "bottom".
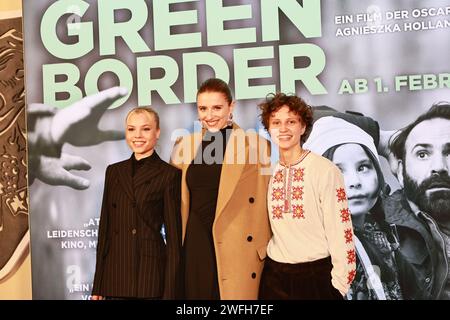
[{"left": 259, "top": 257, "right": 343, "bottom": 300}]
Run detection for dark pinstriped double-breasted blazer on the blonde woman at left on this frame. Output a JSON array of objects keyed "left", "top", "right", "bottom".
[{"left": 92, "top": 152, "right": 181, "bottom": 299}]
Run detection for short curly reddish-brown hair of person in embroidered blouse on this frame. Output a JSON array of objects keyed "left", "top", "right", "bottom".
[{"left": 258, "top": 92, "right": 313, "bottom": 144}]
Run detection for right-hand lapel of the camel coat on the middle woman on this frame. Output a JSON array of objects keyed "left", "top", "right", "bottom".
[{"left": 216, "top": 124, "right": 248, "bottom": 220}]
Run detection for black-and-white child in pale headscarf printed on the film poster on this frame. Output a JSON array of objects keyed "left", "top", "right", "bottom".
[{"left": 304, "top": 116, "right": 413, "bottom": 300}]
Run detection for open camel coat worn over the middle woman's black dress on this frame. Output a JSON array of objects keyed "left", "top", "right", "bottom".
[{"left": 171, "top": 124, "right": 271, "bottom": 300}]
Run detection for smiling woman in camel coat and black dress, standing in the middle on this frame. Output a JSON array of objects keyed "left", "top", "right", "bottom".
[{"left": 171, "top": 79, "right": 271, "bottom": 299}]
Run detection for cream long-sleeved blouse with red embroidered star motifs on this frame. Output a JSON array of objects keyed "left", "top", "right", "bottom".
[{"left": 267, "top": 151, "right": 356, "bottom": 295}]
